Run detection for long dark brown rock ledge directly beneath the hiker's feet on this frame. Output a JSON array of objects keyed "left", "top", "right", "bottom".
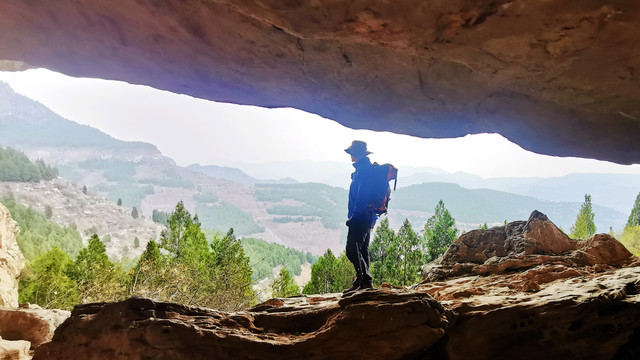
[{"left": 34, "top": 289, "right": 448, "bottom": 360}]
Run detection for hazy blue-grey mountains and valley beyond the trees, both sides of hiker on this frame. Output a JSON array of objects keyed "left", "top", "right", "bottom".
[{"left": 0, "top": 83, "right": 640, "bottom": 254}]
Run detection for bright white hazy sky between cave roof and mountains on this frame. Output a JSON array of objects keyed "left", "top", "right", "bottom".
[{"left": 0, "top": 69, "right": 640, "bottom": 178}]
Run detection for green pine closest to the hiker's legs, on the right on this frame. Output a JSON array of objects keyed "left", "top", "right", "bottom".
[{"left": 369, "top": 217, "right": 399, "bottom": 286}]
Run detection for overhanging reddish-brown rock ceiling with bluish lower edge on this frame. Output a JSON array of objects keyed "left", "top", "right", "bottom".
[{"left": 0, "top": 0, "right": 640, "bottom": 163}]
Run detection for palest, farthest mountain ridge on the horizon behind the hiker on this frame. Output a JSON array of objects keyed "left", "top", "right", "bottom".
[{"left": 225, "top": 156, "right": 640, "bottom": 214}]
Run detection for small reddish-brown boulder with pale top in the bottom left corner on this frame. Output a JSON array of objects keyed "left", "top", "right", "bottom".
[{"left": 0, "top": 304, "right": 71, "bottom": 348}]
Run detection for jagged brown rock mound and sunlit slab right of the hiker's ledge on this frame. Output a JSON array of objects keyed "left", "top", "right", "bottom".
[{"left": 416, "top": 212, "right": 640, "bottom": 360}]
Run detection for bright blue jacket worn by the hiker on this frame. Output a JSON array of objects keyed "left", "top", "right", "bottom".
[{"left": 347, "top": 157, "right": 378, "bottom": 226}]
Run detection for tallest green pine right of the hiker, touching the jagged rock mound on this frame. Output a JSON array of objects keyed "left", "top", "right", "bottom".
[{"left": 423, "top": 200, "right": 458, "bottom": 261}]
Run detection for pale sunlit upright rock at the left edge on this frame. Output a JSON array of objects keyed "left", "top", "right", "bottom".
[{"left": 0, "top": 204, "right": 25, "bottom": 307}]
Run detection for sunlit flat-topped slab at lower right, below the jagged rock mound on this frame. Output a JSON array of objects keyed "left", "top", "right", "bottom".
[{"left": 416, "top": 267, "right": 640, "bottom": 360}]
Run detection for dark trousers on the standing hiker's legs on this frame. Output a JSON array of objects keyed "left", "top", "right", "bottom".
[{"left": 346, "top": 222, "right": 372, "bottom": 285}]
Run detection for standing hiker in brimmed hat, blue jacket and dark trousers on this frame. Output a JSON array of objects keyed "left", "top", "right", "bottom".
[{"left": 344, "top": 140, "right": 378, "bottom": 293}]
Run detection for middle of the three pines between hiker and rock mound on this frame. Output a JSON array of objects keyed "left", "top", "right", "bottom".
[{"left": 394, "top": 219, "right": 424, "bottom": 286}]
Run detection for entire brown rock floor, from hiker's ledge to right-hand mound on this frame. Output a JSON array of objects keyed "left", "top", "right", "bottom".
[{"left": 34, "top": 212, "right": 640, "bottom": 360}]
